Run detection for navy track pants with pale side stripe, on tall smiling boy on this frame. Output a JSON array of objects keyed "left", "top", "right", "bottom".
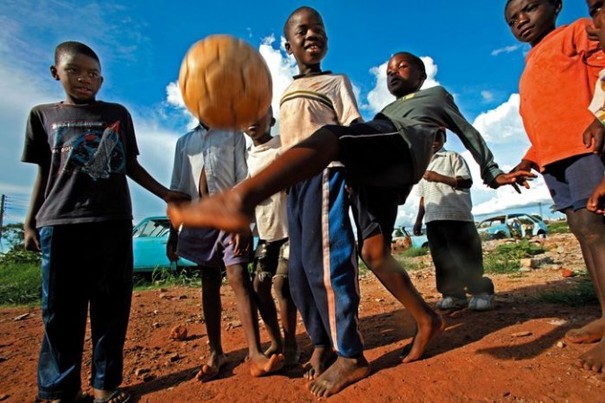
[{"left": 288, "top": 168, "right": 363, "bottom": 358}]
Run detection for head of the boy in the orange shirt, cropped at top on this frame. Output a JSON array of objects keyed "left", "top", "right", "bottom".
[{"left": 504, "top": 0, "right": 562, "bottom": 46}]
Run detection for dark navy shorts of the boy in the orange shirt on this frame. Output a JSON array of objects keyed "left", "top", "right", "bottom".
[{"left": 542, "top": 154, "right": 605, "bottom": 212}]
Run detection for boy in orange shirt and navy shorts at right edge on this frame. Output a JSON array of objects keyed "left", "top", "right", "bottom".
[{"left": 504, "top": 0, "right": 605, "bottom": 371}]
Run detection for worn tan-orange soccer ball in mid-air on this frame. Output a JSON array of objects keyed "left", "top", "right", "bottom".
[{"left": 179, "top": 35, "right": 272, "bottom": 130}]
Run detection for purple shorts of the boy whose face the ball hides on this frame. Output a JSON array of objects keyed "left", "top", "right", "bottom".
[{"left": 176, "top": 227, "right": 250, "bottom": 267}]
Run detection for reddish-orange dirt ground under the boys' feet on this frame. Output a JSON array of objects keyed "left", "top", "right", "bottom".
[{"left": 0, "top": 235, "right": 605, "bottom": 402}]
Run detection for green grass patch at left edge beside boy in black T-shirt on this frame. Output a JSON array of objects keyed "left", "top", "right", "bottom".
[{"left": 0, "top": 262, "right": 42, "bottom": 305}]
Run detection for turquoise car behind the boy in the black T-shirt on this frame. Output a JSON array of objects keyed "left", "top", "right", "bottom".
[{"left": 132, "top": 216, "right": 196, "bottom": 272}]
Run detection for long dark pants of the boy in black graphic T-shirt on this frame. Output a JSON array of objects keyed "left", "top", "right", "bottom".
[{"left": 38, "top": 221, "right": 132, "bottom": 400}]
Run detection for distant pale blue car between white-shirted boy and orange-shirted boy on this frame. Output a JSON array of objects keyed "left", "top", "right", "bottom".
[{"left": 477, "top": 213, "right": 548, "bottom": 239}]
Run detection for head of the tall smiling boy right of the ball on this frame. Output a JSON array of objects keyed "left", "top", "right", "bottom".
[{"left": 285, "top": 8, "right": 328, "bottom": 74}]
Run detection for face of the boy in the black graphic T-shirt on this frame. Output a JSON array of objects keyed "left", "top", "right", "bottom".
[{"left": 50, "top": 52, "right": 103, "bottom": 104}]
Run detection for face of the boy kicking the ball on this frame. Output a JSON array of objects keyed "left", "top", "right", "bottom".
[{"left": 387, "top": 53, "right": 426, "bottom": 98}]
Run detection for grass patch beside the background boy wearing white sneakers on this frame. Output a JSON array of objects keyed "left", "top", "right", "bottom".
[{"left": 483, "top": 239, "right": 544, "bottom": 274}]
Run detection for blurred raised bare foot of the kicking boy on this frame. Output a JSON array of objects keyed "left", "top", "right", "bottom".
[{"left": 167, "top": 190, "right": 252, "bottom": 232}]
